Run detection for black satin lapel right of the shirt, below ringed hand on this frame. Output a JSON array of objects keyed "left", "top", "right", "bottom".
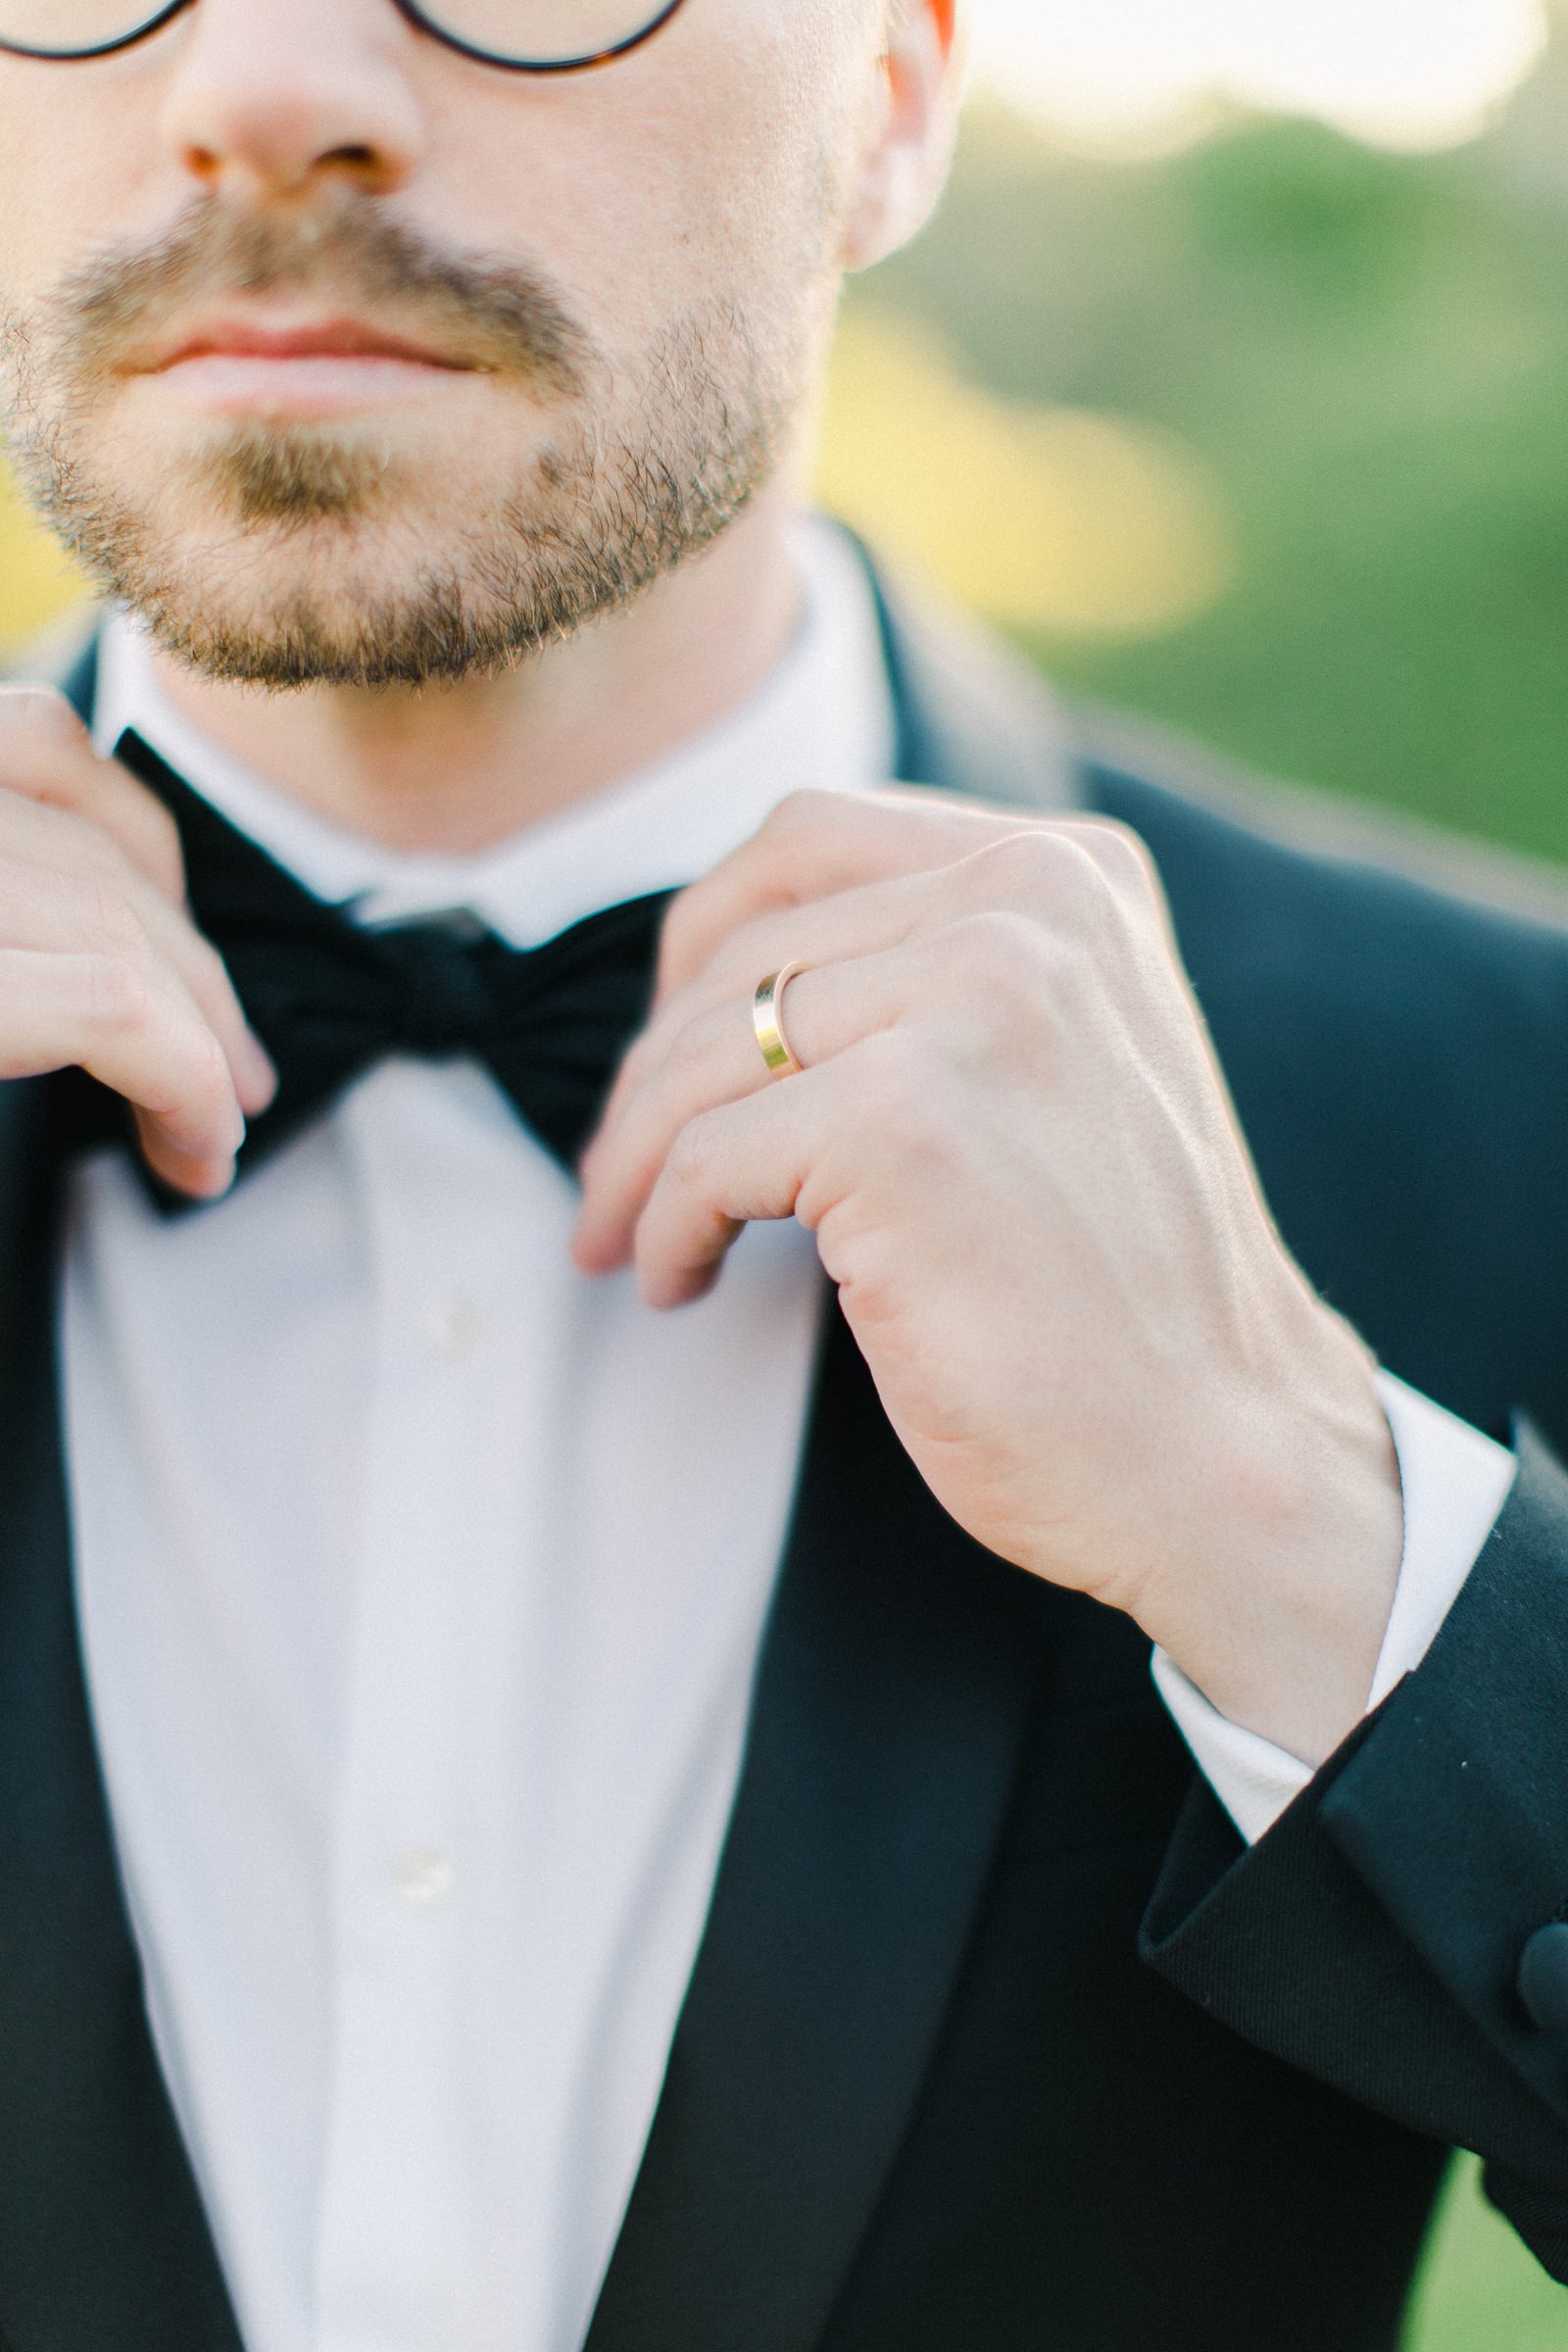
[{"left": 588, "top": 1315, "right": 1042, "bottom": 2352}]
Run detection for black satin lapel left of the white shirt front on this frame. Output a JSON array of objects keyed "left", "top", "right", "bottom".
[{"left": 0, "top": 1082, "right": 240, "bottom": 2352}]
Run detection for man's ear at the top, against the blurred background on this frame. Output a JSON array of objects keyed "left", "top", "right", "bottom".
[{"left": 844, "top": 0, "right": 961, "bottom": 270}]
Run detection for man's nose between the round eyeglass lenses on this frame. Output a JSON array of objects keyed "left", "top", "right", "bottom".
[{"left": 160, "top": 0, "right": 425, "bottom": 202}]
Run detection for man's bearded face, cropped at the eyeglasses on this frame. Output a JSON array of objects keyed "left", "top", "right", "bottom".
[{"left": 0, "top": 0, "right": 886, "bottom": 684}]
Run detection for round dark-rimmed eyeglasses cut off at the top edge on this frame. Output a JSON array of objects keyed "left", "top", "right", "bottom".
[{"left": 0, "top": 0, "right": 684, "bottom": 73}]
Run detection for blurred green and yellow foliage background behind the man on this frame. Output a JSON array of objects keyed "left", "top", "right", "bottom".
[{"left": 0, "top": 0, "right": 1568, "bottom": 2352}]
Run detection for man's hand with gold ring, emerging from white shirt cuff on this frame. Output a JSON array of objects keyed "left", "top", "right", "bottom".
[{"left": 576, "top": 793, "right": 1403, "bottom": 1764}]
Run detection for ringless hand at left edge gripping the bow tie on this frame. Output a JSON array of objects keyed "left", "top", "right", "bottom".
[{"left": 0, "top": 687, "right": 277, "bottom": 1200}]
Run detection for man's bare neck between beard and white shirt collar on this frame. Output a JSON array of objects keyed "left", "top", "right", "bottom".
[{"left": 146, "top": 484, "right": 800, "bottom": 854}]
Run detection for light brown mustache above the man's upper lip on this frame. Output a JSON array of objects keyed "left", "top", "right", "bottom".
[{"left": 49, "top": 195, "right": 595, "bottom": 395}]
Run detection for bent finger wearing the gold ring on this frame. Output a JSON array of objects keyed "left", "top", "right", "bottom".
[{"left": 582, "top": 946, "right": 911, "bottom": 1272}]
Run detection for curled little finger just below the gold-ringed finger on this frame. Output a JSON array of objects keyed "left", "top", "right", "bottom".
[{"left": 637, "top": 1070, "right": 835, "bottom": 1307}]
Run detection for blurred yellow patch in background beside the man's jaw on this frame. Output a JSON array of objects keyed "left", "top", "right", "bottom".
[{"left": 818, "top": 313, "right": 1232, "bottom": 640}]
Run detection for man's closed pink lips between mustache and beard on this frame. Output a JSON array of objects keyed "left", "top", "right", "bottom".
[{"left": 135, "top": 316, "right": 494, "bottom": 418}]
